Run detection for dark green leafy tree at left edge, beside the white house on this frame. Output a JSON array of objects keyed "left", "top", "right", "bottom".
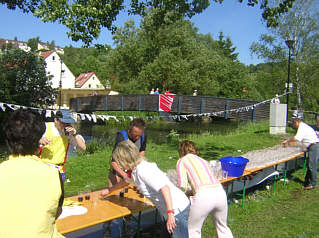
[{"left": 0, "top": 49, "right": 57, "bottom": 107}]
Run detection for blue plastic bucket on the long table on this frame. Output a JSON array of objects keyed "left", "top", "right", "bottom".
[{"left": 219, "top": 156, "right": 249, "bottom": 177}]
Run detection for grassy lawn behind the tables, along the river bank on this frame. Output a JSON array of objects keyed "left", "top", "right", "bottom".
[{"left": 65, "top": 122, "right": 280, "bottom": 196}]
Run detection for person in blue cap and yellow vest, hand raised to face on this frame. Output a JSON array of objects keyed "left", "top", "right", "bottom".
[{"left": 39, "top": 109, "right": 86, "bottom": 181}]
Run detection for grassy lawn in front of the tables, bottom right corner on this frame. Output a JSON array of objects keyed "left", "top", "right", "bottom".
[{"left": 202, "top": 169, "right": 319, "bottom": 238}]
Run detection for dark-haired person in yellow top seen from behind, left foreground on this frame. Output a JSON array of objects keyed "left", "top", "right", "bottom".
[{"left": 0, "top": 110, "right": 64, "bottom": 238}]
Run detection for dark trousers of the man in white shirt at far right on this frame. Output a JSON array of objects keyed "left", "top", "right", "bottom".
[{"left": 304, "top": 144, "right": 319, "bottom": 187}]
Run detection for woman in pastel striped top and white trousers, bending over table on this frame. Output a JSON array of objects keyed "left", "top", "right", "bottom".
[{"left": 176, "top": 140, "right": 233, "bottom": 238}]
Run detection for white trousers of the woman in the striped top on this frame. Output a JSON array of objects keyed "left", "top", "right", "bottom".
[{"left": 188, "top": 185, "right": 233, "bottom": 238}]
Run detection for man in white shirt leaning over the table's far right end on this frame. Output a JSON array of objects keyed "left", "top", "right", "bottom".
[{"left": 282, "top": 117, "right": 319, "bottom": 190}]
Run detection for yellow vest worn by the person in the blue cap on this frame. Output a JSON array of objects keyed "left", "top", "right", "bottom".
[{"left": 40, "top": 122, "right": 69, "bottom": 171}]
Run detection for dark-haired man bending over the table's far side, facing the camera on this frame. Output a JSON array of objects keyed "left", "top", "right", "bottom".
[{"left": 109, "top": 118, "right": 147, "bottom": 187}]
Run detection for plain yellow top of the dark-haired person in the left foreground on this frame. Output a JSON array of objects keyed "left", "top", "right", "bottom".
[{"left": 0, "top": 155, "right": 63, "bottom": 238}]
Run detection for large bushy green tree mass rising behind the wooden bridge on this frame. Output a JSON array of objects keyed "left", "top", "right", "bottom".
[{"left": 106, "top": 14, "right": 260, "bottom": 98}]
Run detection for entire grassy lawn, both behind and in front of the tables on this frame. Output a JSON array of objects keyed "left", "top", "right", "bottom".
[{"left": 65, "top": 122, "right": 319, "bottom": 238}]
